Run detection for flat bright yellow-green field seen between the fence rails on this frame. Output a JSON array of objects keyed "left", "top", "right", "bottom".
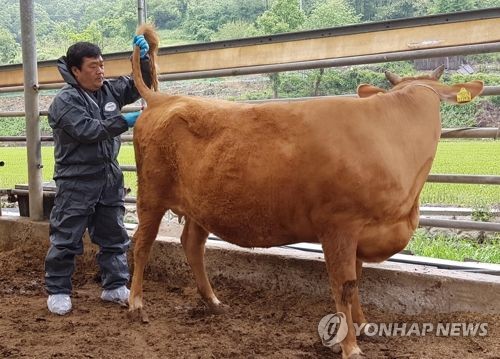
[{"left": 0, "top": 140, "right": 500, "bottom": 207}]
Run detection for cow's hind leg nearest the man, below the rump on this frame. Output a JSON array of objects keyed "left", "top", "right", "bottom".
[{"left": 129, "top": 206, "right": 165, "bottom": 323}]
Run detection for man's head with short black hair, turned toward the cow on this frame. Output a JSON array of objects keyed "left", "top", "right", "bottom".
[{"left": 66, "top": 42, "right": 104, "bottom": 91}]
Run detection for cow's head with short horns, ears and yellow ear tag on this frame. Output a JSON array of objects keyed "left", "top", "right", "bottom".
[{"left": 358, "top": 65, "right": 484, "bottom": 103}]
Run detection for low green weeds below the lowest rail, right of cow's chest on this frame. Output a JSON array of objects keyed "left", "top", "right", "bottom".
[{"left": 407, "top": 229, "right": 500, "bottom": 263}]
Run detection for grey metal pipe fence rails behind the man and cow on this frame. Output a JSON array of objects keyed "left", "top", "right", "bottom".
[{"left": 0, "top": 8, "right": 500, "bottom": 232}]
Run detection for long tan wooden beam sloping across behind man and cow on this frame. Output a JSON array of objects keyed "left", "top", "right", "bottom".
[{"left": 0, "top": 13, "right": 500, "bottom": 87}]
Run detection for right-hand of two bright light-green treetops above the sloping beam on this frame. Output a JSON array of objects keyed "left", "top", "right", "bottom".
[{"left": 303, "top": 0, "right": 361, "bottom": 29}]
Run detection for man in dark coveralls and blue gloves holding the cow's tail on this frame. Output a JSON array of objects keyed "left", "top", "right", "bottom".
[{"left": 45, "top": 36, "right": 151, "bottom": 315}]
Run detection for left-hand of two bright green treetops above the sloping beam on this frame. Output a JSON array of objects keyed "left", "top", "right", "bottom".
[{"left": 256, "top": 0, "right": 306, "bottom": 34}]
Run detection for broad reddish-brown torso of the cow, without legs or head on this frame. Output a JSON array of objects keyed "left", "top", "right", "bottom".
[{"left": 136, "top": 89, "right": 439, "bottom": 246}]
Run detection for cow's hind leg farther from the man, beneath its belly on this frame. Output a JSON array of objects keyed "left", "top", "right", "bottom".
[{"left": 181, "top": 218, "right": 225, "bottom": 314}]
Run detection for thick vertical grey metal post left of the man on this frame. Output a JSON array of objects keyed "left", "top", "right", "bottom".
[{"left": 19, "top": 0, "right": 43, "bottom": 221}]
